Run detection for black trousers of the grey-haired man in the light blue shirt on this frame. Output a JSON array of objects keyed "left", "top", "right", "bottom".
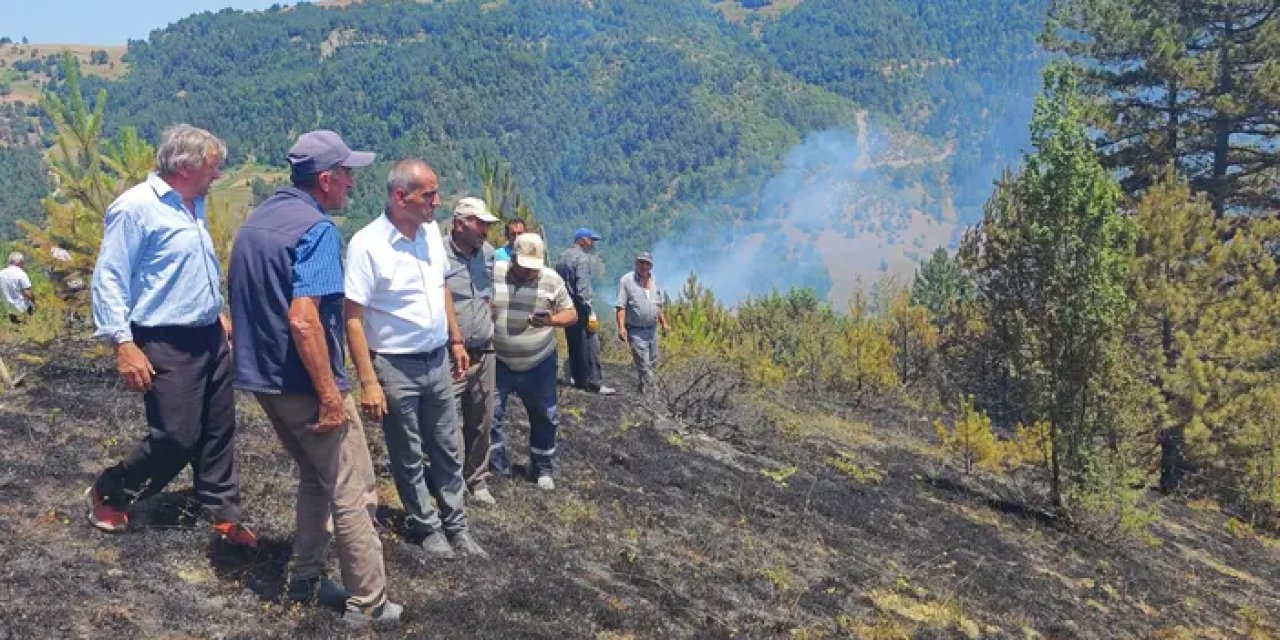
[{"left": 93, "top": 323, "right": 241, "bottom": 522}]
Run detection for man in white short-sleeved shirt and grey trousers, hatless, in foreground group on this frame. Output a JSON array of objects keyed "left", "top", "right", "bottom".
[{"left": 343, "top": 160, "right": 488, "bottom": 558}]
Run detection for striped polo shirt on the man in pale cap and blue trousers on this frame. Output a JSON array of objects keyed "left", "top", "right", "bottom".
[{"left": 493, "top": 262, "right": 573, "bottom": 371}]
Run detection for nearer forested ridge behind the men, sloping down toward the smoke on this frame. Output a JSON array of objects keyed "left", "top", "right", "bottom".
[{"left": 77, "top": 3, "right": 839, "bottom": 271}]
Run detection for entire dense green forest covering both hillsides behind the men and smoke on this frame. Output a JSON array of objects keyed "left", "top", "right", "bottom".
[{"left": 5, "top": 0, "right": 1043, "bottom": 284}]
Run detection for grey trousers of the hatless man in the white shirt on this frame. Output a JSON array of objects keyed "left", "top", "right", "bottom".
[{"left": 374, "top": 347, "right": 467, "bottom": 539}]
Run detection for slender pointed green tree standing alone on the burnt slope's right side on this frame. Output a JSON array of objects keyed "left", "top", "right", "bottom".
[{"left": 961, "top": 65, "right": 1133, "bottom": 506}]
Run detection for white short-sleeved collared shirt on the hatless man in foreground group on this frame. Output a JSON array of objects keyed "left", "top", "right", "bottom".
[{"left": 344, "top": 212, "right": 449, "bottom": 353}]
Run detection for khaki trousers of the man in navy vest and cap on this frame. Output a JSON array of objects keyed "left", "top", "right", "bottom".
[{"left": 253, "top": 393, "right": 387, "bottom": 607}]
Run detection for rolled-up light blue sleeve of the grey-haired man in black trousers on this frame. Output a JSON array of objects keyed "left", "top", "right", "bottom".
[{"left": 91, "top": 209, "right": 146, "bottom": 344}]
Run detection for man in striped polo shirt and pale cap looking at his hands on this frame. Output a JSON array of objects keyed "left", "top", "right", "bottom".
[{"left": 489, "top": 233, "right": 577, "bottom": 490}]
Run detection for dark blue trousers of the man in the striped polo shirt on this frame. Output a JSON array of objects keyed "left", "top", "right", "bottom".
[{"left": 489, "top": 353, "right": 559, "bottom": 475}]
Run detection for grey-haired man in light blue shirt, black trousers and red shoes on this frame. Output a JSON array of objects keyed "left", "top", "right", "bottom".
[{"left": 86, "top": 124, "right": 257, "bottom": 547}]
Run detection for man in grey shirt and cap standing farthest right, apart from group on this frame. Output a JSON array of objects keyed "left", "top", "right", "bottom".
[{"left": 614, "top": 251, "right": 669, "bottom": 393}]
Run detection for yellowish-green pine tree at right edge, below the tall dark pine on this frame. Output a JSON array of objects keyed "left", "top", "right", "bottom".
[{"left": 1129, "top": 173, "right": 1280, "bottom": 513}]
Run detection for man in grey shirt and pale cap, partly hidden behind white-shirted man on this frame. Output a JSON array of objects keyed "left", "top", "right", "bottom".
[{"left": 444, "top": 197, "right": 498, "bottom": 504}]
